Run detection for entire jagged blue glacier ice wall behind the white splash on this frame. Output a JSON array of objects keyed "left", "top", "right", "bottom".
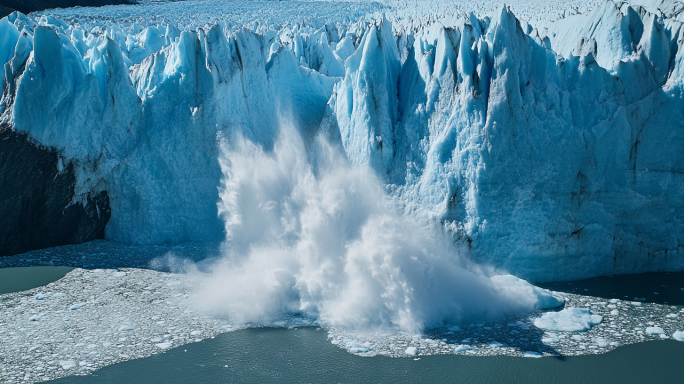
[{"left": 0, "top": 1, "right": 684, "bottom": 281}]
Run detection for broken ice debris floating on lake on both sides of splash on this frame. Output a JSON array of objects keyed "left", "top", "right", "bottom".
[{"left": 0, "top": 241, "right": 684, "bottom": 383}]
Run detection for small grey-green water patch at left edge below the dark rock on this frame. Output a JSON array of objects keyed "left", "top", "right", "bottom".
[{"left": 0, "top": 267, "right": 73, "bottom": 295}]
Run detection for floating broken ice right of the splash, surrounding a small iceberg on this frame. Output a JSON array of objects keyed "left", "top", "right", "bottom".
[{"left": 328, "top": 294, "right": 684, "bottom": 357}]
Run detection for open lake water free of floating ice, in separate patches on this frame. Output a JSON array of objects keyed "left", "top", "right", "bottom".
[{"left": 0, "top": 267, "right": 684, "bottom": 384}]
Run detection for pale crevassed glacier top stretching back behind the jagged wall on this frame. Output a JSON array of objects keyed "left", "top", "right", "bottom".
[{"left": 32, "top": 0, "right": 602, "bottom": 32}]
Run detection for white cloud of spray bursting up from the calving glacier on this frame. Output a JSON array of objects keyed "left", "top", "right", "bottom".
[{"left": 188, "top": 127, "right": 563, "bottom": 332}]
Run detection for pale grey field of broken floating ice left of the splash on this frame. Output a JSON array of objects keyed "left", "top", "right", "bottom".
[{"left": 0, "top": 268, "right": 231, "bottom": 383}]
